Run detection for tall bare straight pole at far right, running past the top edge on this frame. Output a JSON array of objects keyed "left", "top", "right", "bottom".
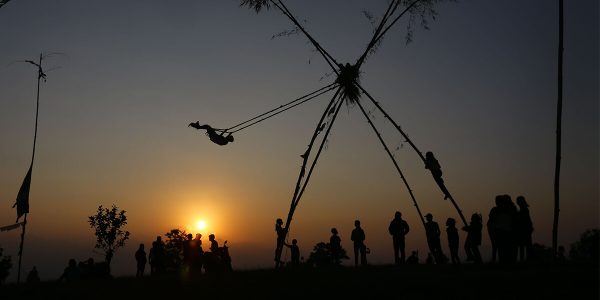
[{"left": 552, "top": 0, "right": 564, "bottom": 258}]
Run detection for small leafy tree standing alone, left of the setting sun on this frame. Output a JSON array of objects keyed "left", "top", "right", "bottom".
[{"left": 88, "top": 204, "right": 129, "bottom": 266}]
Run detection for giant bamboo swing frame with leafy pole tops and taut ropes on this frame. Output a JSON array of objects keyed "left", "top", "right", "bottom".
[{"left": 195, "top": 0, "right": 467, "bottom": 268}]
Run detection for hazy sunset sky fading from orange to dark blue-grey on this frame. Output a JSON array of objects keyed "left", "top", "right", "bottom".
[{"left": 0, "top": 0, "right": 600, "bottom": 280}]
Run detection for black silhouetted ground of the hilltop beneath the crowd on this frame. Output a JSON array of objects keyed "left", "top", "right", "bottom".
[{"left": 0, "top": 265, "right": 600, "bottom": 300}]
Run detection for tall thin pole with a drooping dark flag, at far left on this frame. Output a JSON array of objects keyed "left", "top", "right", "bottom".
[{"left": 13, "top": 53, "right": 46, "bottom": 284}]
